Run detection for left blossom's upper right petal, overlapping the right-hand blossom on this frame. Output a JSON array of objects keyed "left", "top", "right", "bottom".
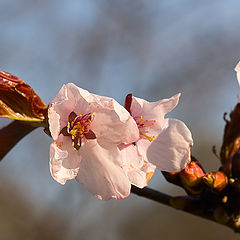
[{"left": 91, "top": 95, "right": 139, "bottom": 147}]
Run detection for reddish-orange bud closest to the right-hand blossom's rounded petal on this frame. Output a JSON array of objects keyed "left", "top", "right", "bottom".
[{"left": 179, "top": 161, "right": 204, "bottom": 194}]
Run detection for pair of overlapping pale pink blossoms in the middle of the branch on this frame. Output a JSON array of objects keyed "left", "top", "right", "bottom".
[{"left": 48, "top": 83, "right": 193, "bottom": 200}]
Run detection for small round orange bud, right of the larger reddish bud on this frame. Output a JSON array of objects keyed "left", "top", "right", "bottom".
[{"left": 203, "top": 171, "right": 228, "bottom": 192}]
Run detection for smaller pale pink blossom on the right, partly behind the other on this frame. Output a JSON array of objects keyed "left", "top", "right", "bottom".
[{"left": 119, "top": 94, "right": 193, "bottom": 188}]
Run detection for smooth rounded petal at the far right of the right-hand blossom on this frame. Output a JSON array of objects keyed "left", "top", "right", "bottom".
[{"left": 147, "top": 119, "right": 193, "bottom": 172}]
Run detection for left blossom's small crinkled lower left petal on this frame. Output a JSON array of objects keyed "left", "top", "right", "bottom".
[{"left": 50, "top": 135, "right": 81, "bottom": 184}]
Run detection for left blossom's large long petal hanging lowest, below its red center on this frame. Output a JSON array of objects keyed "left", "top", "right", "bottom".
[{"left": 76, "top": 140, "right": 131, "bottom": 200}]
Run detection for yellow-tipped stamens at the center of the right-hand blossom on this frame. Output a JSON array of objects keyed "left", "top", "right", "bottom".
[{"left": 134, "top": 116, "right": 156, "bottom": 142}]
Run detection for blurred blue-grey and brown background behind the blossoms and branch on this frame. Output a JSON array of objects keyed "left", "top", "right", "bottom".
[{"left": 0, "top": 0, "right": 240, "bottom": 240}]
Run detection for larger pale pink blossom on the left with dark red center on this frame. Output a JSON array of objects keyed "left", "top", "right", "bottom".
[{"left": 48, "top": 83, "right": 139, "bottom": 200}]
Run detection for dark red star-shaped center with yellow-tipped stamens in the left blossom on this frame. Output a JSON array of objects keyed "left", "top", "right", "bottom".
[{"left": 60, "top": 112, "right": 96, "bottom": 150}]
